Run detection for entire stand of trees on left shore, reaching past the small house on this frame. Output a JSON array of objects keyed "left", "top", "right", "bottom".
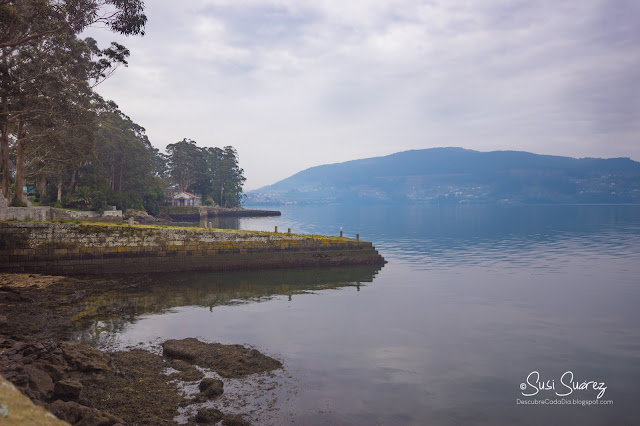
[{"left": 0, "top": 0, "right": 245, "bottom": 214}]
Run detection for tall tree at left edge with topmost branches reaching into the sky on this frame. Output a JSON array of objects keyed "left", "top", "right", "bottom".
[{"left": 0, "top": 0, "right": 146, "bottom": 197}]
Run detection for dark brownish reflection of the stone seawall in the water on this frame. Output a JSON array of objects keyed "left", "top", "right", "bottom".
[{"left": 74, "top": 265, "right": 382, "bottom": 344}]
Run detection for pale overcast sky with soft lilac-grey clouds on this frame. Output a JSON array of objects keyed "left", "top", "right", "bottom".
[{"left": 84, "top": 0, "right": 640, "bottom": 190}]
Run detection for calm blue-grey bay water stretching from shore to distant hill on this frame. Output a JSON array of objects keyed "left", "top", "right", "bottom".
[{"left": 74, "top": 206, "right": 640, "bottom": 425}]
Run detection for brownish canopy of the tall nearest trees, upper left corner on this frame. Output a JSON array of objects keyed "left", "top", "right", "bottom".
[{"left": 0, "top": 0, "right": 147, "bottom": 204}]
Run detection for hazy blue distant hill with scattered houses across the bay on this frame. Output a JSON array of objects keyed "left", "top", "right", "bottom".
[{"left": 247, "top": 148, "right": 640, "bottom": 204}]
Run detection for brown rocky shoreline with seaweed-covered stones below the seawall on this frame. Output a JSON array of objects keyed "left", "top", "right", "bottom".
[{"left": 0, "top": 274, "right": 282, "bottom": 426}]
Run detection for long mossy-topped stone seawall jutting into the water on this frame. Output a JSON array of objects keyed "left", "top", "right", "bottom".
[{"left": 0, "top": 222, "right": 385, "bottom": 275}]
